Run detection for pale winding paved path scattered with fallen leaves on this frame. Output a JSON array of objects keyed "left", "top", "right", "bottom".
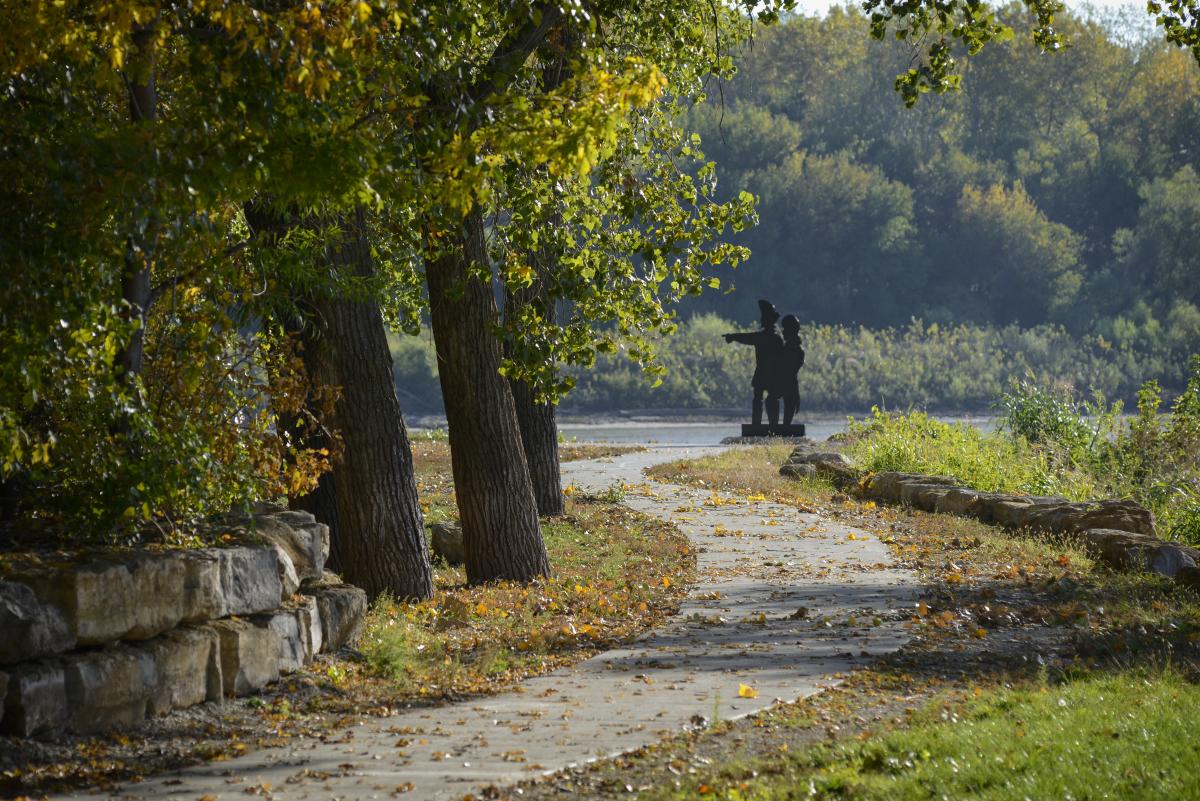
[{"left": 58, "top": 448, "right": 919, "bottom": 801}]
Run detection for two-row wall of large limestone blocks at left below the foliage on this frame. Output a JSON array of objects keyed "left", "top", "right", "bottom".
[{"left": 0, "top": 507, "right": 367, "bottom": 736}]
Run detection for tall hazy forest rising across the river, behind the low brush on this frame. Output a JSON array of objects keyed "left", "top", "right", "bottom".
[{"left": 689, "top": 5, "right": 1200, "bottom": 342}]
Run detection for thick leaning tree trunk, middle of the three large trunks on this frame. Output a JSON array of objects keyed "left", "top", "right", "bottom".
[{"left": 426, "top": 210, "right": 550, "bottom": 584}]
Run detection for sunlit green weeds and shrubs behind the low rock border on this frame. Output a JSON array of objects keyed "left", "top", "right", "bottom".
[{"left": 848, "top": 355, "right": 1200, "bottom": 543}]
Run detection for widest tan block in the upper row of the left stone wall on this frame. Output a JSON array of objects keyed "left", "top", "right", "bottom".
[{"left": 13, "top": 550, "right": 186, "bottom": 645}]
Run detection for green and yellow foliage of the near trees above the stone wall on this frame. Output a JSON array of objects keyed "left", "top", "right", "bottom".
[{"left": 0, "top": 0, "right": 778, "bottom": 540}]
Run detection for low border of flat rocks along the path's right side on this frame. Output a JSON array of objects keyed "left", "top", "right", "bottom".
[{"left": 779, "top": 445, "right": 1200, "bottom": 589}]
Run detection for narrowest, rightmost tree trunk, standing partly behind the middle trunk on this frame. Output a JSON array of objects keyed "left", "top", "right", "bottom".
[{"left": 504, "top": 287, "right": 565, "bottom": 517}]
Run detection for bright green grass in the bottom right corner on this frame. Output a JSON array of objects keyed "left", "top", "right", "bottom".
[{"left": 665, "top": 671, "right": 1200, "bottom": 801}]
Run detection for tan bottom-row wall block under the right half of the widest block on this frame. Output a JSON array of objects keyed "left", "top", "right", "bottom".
[{"left": 139, "top": 627, "right": 222, "bottom": 716}]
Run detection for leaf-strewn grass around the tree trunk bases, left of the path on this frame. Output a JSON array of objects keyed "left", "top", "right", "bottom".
[{"left": 359, "top": 440, "right": 696, "bottom": 698}]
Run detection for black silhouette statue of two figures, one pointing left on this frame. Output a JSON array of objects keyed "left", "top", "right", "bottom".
[{"left": 725, "top": 300, "right": 804, "bottom": 436}]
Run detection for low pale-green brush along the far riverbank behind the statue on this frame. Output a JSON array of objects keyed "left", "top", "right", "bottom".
[{"left": 392, "top": 314, "right": 1200, "bottom": 414}]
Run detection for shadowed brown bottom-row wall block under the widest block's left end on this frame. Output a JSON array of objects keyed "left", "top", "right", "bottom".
[{"left": 64, "top": 645, "right": 158, "bottom": 733}]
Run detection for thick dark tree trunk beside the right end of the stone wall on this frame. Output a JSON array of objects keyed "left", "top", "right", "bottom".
[{"left": 311, "top": 210, "right": 433, "bottom": 598}]
